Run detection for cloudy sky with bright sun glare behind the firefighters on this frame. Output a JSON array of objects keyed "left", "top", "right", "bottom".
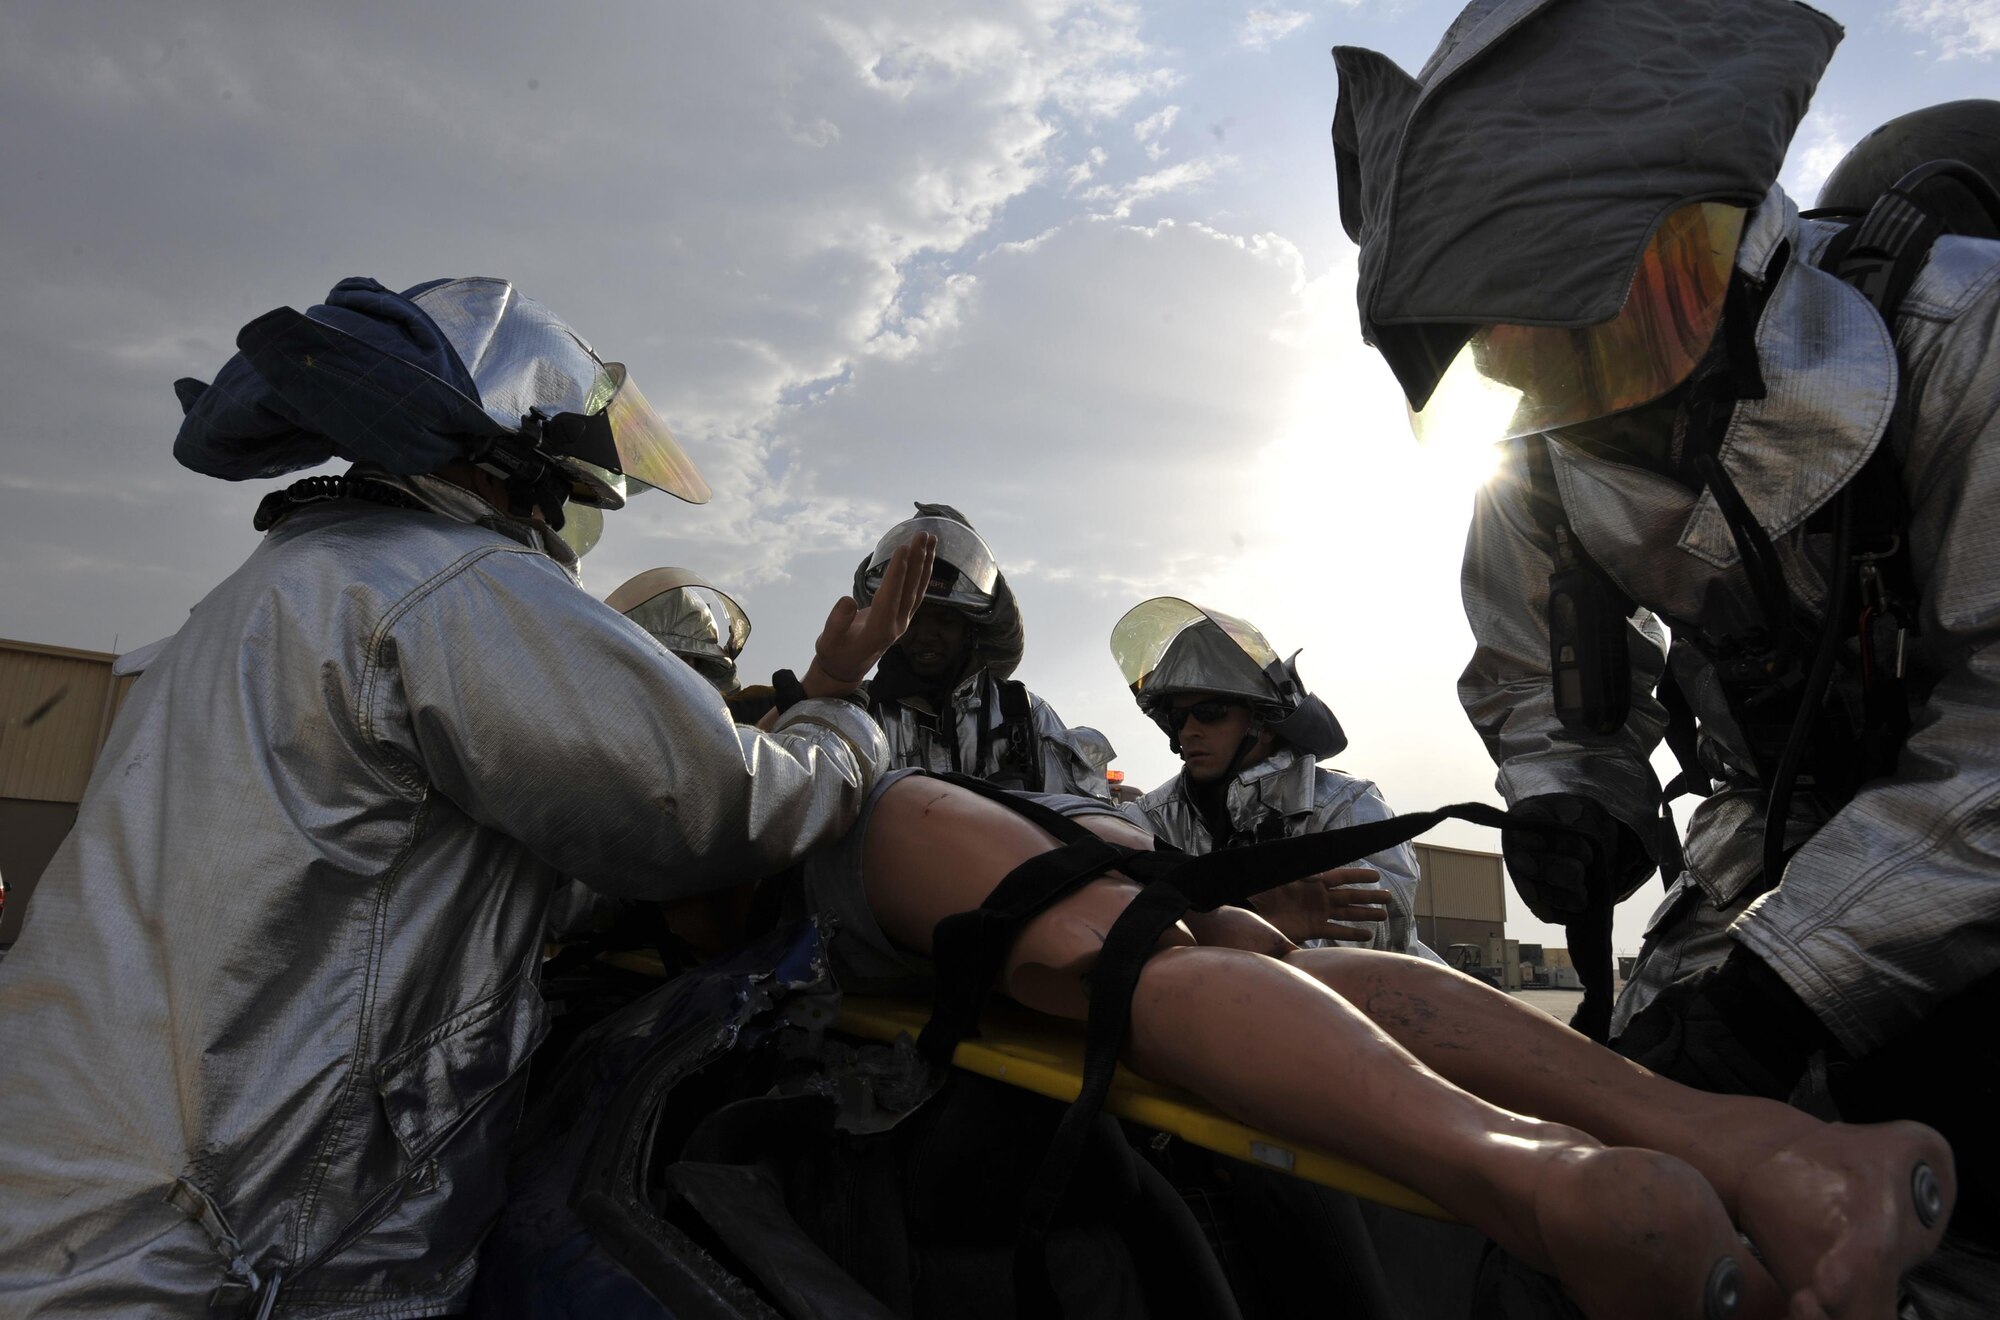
[{"left": 0, "top": 0, "right": 2000, "bottom": 952}]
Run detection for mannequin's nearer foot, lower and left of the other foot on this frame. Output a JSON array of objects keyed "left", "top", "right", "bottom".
[{"left": 1534, "top": 1146, "right": 1784, "bottom": 1320}]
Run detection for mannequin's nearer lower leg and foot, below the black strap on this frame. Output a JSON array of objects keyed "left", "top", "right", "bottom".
[{"left": 1128, "top": 948, "right": 1778, "bottom": 1320}]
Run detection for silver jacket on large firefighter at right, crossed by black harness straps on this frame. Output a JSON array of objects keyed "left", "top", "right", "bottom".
[{"left": 1458, "top": 188, "right": 2000, "bottom": 1052}]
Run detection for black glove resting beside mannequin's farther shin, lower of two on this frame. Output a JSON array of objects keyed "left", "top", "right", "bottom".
[{"left": 1612, "top": 948, "right": 1836, "bottom": 1100}]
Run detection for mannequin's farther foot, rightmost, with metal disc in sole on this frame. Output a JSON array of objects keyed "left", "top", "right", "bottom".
[{"left": 1738, "top": 1122, "right": 1958, "bottom": 1320}]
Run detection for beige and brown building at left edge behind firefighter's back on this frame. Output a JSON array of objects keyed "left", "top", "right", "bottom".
[{"left": 0, "top": 638, "right": 134, "bottom": 946}]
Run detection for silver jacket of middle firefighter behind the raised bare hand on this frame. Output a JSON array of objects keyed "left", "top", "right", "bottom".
[{"left": 874, "top": 668, "right": 1114, "bottom": 802}]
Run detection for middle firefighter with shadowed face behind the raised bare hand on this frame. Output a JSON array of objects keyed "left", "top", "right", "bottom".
[{"left": 854, "top": 504, "right": 1114, "bottom": 800}]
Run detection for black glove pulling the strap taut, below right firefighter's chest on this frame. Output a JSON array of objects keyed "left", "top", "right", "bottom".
[{"left": 1500, "top": 792, "right": 1650, "bottom": 926}]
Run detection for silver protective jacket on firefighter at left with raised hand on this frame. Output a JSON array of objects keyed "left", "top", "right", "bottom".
[{"left": 0, "top": 478, "right": 884, "bottom": 1320}]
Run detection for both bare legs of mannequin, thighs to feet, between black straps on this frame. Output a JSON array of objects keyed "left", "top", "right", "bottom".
[{"left": 864, "top": 780, "right": 1950, "bottom": 1318}]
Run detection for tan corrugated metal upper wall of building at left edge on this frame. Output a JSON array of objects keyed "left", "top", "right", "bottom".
[{"left": 0, "top": 638, "right": 134, "bottom": 802}]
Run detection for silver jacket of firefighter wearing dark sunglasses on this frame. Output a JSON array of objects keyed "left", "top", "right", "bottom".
[{"left": 1118, "top": 748, "right": 1438, "bottom": 960}]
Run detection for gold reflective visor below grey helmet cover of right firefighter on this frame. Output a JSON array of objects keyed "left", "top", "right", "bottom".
[{"left": 1410, "top": 202, "right": 1746, "bottom": 444}]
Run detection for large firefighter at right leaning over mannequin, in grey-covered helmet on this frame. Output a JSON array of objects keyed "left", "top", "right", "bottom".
[{"left": 1334, "top": 0, "right": 2000, "bottom": 1314}]
